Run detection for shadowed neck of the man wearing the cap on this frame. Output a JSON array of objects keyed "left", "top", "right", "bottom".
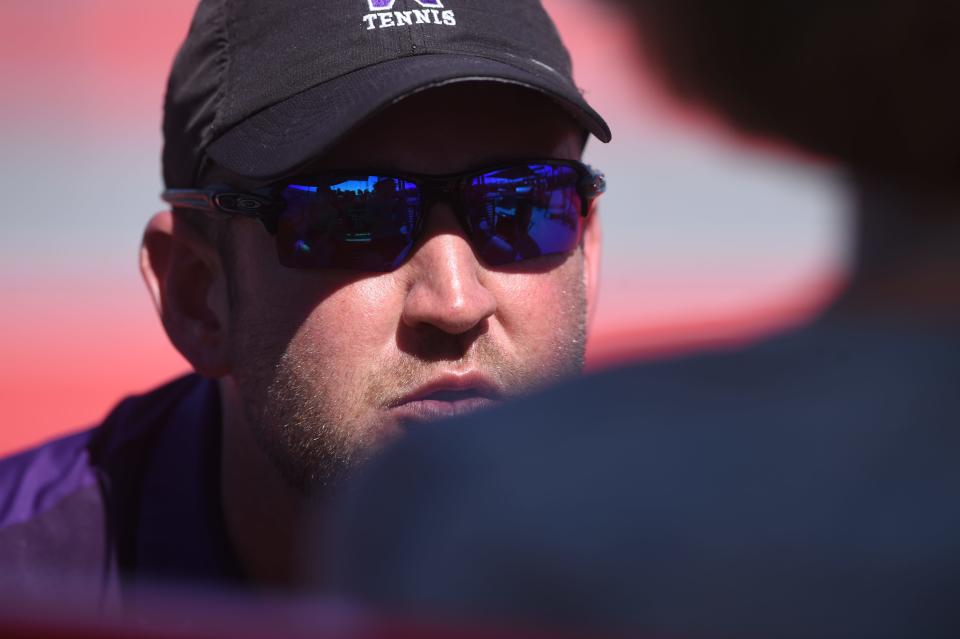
[{"left": 220, "top": 379, "right": 316, "bottom": 589}]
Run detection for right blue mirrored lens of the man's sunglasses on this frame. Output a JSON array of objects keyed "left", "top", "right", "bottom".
[{"left": 464, "top": 164, "right": 583, "bottom": 265}]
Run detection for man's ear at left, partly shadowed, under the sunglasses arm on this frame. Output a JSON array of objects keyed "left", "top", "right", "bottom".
[{"left": 140, "top": 211, "right": 230, "bottom": 377}]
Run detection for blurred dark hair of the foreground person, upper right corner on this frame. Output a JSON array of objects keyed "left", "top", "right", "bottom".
[{"left": 620, "top": 0, "right": 960, "bottom": 187}]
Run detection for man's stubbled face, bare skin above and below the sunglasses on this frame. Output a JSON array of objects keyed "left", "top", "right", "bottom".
[{"left": 217, "top": 83, "right": 593, "bottom": 489}]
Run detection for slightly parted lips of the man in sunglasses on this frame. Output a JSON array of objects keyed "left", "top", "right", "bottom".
[{"left": 390, "top": 374, "right": 503, "bottom": 423}]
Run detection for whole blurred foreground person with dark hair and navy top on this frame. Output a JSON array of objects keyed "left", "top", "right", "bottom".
[{"left": 327, "top": 0, "right": 960, "bottom": 639}]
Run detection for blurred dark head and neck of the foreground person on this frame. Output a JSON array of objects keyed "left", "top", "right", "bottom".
[{"left": 619, "top": 0, "right": 960, "bottom": 322}]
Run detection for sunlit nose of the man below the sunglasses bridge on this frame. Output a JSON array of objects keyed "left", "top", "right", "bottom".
[{"left": 403, "top": 204, "right": 497, "bottom": 335}]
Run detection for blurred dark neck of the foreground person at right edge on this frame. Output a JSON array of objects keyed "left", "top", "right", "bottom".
[{"left": 837, "top": 179, "right": 960, "bottom": 324}]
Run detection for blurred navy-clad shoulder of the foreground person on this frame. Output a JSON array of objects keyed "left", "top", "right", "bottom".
[{"left": 325, "top": 319, "right": 960, "bottom": 636}]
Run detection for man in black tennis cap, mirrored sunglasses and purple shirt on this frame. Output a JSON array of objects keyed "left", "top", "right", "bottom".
[{"left": 0, "top": 0, "right": 610, "bottom": 606}]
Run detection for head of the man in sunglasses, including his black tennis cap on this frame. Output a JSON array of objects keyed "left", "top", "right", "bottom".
[{"left": 143, "top": 0, "right": 608, "bottom": 493}]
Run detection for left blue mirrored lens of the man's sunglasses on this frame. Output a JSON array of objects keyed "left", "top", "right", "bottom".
[{"left": 277, "top": 176, "right": 420, "bottom": 271}]
